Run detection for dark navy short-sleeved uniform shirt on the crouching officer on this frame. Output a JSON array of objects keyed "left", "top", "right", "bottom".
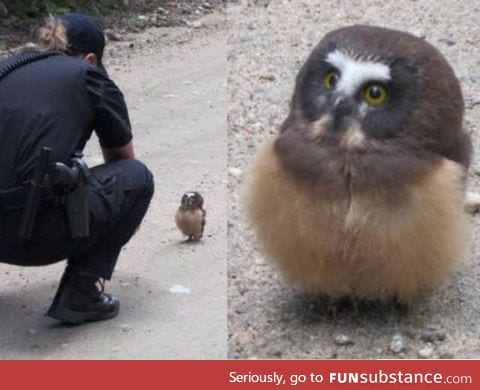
[{"left": 0, "top": 55, "right": 132, "bottom": 190}]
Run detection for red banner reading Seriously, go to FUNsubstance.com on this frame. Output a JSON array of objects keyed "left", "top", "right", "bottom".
[{"left": 0, "top": 360, "right": 480, "bottom": 390}]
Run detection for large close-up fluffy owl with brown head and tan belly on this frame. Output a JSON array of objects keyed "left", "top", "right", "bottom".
[{"left": 247, "top": 25, "right": 471, "bottom": 302}]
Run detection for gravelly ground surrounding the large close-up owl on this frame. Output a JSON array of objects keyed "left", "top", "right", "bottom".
[{"left": 228, "top": 0, "right": 480, "bottom": 358}]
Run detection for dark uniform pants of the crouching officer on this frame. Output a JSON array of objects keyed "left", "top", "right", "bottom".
[{"left": 0, "top": 159, "right": 154, "bottom": 279}]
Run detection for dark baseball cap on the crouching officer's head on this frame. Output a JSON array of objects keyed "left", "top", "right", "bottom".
[{"left": 60, "top": 13, "right": 105, "bottom": 69}]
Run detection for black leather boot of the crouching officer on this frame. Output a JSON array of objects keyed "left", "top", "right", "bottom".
[{"left": 47, "top": 266, "right": 120, "bottom": 324}]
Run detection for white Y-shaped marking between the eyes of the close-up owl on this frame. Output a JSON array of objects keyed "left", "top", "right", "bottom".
[{"left": 326, "top": 50, "right": 390, "bottom": 96}]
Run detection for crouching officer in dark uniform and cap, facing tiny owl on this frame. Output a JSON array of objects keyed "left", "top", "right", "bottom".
[{"left": 0, "top": 14, "right": 154, "bottom": 324}]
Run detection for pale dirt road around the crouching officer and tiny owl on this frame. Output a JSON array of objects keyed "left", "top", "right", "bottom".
[{"left": 0, "top": 14, "right": 227, "bottom": 359}]
